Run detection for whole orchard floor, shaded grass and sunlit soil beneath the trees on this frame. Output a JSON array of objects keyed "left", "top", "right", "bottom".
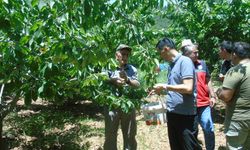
[{"left": 4, "top": 97, "right": 225, "bottom": 150}]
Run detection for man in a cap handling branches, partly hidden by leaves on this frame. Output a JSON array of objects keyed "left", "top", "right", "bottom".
[{"left": 104, "top": 44, "right": 140, "bottom": 150}]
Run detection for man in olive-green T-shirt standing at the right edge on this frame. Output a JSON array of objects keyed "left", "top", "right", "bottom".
[{"left": 216, "top": 42, "right": 250, "bottom": 150}]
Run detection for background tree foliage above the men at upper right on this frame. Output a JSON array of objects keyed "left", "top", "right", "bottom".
[{"left": 162, "top": 0, "right": 250, "bottom": 68}]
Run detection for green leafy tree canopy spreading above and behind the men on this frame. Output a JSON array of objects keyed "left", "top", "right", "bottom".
[{"left": 0, "top": 0, "right": 250, "bottom": 110}]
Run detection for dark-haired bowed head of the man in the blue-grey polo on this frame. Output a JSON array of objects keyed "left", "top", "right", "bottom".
[{"left": 156, "top": 38, "right": 175, "bottom": 61}]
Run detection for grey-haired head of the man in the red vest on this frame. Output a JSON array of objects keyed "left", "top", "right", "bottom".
[{"left": 181, "top": 44, "right": 198, "bottom": 62}]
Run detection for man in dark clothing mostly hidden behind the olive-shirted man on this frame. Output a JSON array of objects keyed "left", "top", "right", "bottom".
[{"left": 219, "top": 41, "right": 233, "bottom": 82}]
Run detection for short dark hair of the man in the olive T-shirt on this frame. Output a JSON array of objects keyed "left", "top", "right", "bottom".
[{"left": 233, "top": 42, "right": 250, "bottom": 58}]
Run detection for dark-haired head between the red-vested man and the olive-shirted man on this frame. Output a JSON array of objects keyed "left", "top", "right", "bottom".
[{"left": 219, "top": 41, "right": 233, "bottom": 60}]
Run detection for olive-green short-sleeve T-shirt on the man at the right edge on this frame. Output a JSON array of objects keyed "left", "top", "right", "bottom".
[{"left": 223, "top": 63, "right": 250, "bottom": 130}]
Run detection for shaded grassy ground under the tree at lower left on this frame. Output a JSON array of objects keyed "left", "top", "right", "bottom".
[{"left": 4, "top": 99, "right": 104, "bottom": 150}]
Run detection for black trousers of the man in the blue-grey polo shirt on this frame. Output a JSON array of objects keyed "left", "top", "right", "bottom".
[{"left": 167, "top": 112, "right": 202, "bottom": 150}]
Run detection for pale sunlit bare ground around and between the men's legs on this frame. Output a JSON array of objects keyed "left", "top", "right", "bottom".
[{"left": 75, "top": 101, "right": 226, "bottom": 150}]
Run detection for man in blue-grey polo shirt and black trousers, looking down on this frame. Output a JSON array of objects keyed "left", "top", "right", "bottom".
[{"left": 154, "top": 38, "right": 201, "bottom": 150}]
